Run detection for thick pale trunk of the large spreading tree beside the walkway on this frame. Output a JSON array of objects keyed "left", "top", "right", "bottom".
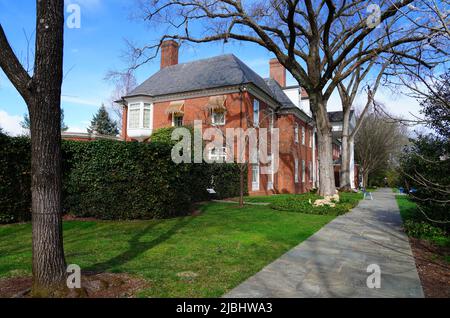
[{"left": 310, "top": 93, "right": 336, "bottom": 196}]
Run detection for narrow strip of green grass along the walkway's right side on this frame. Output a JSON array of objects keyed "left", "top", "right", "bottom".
[{"left": 395, "top": 195, "right": 450, "bottom": 246}]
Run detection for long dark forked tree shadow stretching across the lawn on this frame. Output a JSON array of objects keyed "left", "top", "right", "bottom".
[{"left": 86, "top": 217, "right": 192, "bottom": 272}]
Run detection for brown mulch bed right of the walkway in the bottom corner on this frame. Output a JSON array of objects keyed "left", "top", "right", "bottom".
[{"left": 409, "top": 238, "right": 450, "bottom": 298}]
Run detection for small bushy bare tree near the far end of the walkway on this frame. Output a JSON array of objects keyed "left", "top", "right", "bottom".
[{"left": 355, "top": 113, "right": 407, "bottom": 187}]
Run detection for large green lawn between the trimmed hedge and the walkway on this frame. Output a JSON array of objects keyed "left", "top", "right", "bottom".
[{"left": 0, "top": 203, "right": 334, "bottom": 297}]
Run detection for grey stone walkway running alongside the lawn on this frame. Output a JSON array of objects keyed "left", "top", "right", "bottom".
[{"left": 224, "top": 189, "right": 423, "bottom": 298}]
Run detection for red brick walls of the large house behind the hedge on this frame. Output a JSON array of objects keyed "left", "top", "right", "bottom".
[{"left": 122, "top": 92, "right": 317, "bottom": 195}]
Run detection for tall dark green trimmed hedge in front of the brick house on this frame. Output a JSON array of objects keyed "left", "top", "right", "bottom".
[{"left": 0, "top": 136, "right": 246, "bottom": 223}]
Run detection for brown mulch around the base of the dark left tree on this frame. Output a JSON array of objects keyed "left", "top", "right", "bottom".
[{"left": 0, "top": 273, "right": 149, "bottom": 298}]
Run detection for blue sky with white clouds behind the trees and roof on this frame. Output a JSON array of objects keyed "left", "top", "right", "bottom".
[{"left": 0, "top": 0, "right": 418, "bottom": 134}]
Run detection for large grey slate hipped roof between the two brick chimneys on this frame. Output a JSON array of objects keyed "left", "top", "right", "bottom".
[{"left": 128, "top": 54, "right": 273, "bottom": 97}]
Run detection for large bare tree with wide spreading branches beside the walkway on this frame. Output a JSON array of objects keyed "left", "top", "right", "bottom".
[{"left": 127, "top": 0, "right": 436, "bottom": 195}]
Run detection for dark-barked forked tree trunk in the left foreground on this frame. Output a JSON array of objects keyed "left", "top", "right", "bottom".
[{"left": 0, "top": 0, "right": 66, "bottom": 296}]
